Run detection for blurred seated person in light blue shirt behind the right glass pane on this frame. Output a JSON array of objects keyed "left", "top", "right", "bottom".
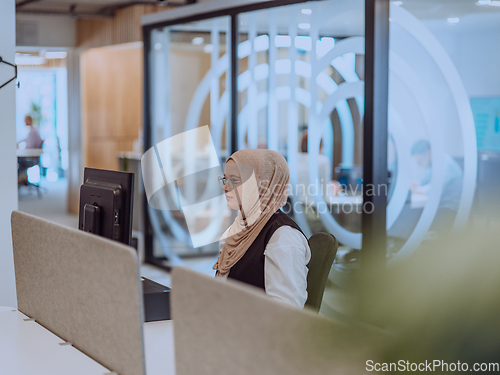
[{"left": 410, "top": 139, "right": 463, "bottom": 231}]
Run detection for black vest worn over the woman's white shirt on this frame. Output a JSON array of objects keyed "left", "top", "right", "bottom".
[{"left": 227, "top": 210, "right": 307, "bottom": 290}]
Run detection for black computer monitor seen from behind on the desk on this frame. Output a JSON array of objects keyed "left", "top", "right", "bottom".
[{"left": 78, "top": 168, "right": 134, "bottom": 245}]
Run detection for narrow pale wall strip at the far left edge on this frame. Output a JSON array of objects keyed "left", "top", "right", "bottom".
[{"left": 0, "top": 0, "right": 17, "bottom": 307}]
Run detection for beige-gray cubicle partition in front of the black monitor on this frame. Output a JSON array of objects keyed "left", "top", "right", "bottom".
[{"left": 12, "top": 211, "right": 145, "bottom": 375}]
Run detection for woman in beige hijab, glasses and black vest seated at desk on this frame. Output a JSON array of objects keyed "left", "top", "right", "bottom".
[{"left": 213, "top": 149, "right": 311, "bottom": 308}]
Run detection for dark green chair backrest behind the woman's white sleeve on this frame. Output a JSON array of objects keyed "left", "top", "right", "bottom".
[{"left": 306, "top": 233, "right": 339, "bottom": 311}]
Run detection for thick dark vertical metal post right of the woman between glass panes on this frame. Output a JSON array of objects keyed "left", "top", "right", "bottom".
[{"left": 358, "top": 0, "right": 389, "bottom": 326}]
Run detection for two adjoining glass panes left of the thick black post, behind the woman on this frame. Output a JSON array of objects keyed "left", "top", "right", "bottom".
[{"left": 145, "top": 0, "right": 365, "bottom": 280}]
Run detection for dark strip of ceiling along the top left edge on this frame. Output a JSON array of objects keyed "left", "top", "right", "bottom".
[{"left": 16, "top": 0, "right": 196, "bottom": 17}]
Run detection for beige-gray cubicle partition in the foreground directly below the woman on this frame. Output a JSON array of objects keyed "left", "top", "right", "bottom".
[{"left": 172, "top": 267, "right": 386, "bottom": 375}]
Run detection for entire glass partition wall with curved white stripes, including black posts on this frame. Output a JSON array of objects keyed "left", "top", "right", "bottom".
[{"left": 144, "top": 0, "right": 500, "bottom": 320}]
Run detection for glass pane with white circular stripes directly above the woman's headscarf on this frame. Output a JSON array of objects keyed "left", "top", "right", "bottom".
[{"left": 237, "top": 1, "right": 364, "bottom": 249}]
